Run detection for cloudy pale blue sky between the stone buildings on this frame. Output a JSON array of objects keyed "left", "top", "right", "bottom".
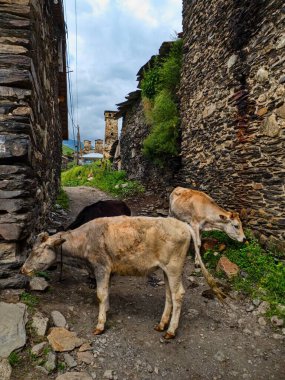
[{"left": 64, "top": 0, "right": 182, "bottom": 142}]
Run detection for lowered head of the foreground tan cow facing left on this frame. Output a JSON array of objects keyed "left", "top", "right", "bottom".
[{"left": 21, "top": 233, "right": 65, "bottom": 276}]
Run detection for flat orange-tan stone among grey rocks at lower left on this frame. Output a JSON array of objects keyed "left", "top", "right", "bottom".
[{"left": 47, "top": 327, "right": 84, "bottom": 352}]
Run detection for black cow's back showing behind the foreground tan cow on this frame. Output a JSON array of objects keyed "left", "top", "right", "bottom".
[{"left": 65, "top": 199, "right": 131, "bottom": 231}]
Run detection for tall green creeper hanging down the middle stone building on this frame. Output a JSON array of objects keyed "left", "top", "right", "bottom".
[{"left": 141, "top": 39, "right": 182, "bottom": 167}]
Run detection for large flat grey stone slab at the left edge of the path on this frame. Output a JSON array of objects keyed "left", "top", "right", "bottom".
[{"left": 0, "top": 302, "right": 27, "bottom": 358}]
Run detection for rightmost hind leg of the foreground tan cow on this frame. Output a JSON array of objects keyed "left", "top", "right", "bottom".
[{"left": 164, "top": 273, "right": 185, "bottom": 339}]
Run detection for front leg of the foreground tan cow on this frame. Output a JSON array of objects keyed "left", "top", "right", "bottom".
[{"left": 94, "top": 267, "right": 110, "bottom": 335}]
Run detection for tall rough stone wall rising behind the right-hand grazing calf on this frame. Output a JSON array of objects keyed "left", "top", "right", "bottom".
[{"left": 180, "top": 0, "right": 285, "bottom": 250}]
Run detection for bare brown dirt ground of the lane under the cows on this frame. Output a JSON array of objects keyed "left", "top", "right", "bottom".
[{"left": 12, "top": 187, "right": 285, "bottom": 380}]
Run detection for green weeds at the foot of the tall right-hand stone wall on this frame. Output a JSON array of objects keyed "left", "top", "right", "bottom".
[{"left": 203, "top": 231, "right": 285, "bottom": 317}]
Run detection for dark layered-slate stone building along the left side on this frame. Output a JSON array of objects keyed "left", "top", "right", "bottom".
[{"left": 0, "top": 0, "right": 68, "bottom": 288}]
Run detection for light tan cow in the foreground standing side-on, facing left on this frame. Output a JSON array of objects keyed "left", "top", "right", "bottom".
[{"left": 22, "top": 216, "right": 191, "bottom": 339}]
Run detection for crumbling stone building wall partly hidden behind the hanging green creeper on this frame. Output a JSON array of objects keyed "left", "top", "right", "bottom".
[{"left": 115, "top": 42, "right": 180, "bottom": 196}]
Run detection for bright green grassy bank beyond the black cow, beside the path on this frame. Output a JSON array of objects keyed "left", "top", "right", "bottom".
[{"left": 61, "top": 161, "right": 144, "bottom": 198}]
